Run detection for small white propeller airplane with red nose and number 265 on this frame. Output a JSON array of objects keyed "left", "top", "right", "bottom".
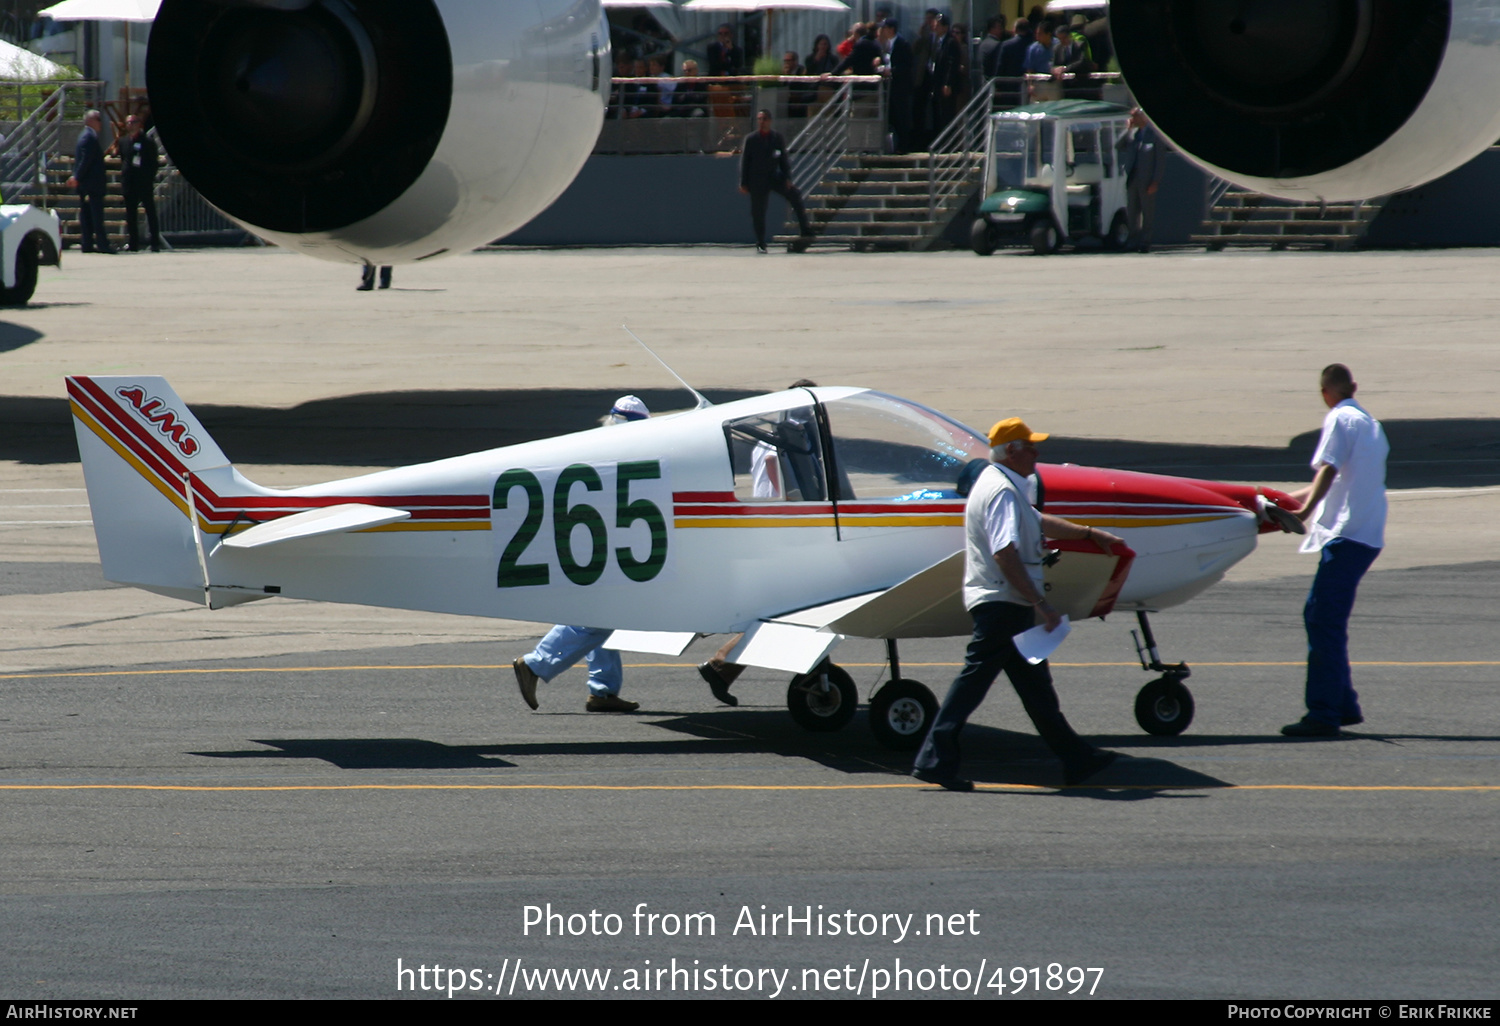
[{"left": 68, "top": 377, "right": 1295, "bottom": 749}]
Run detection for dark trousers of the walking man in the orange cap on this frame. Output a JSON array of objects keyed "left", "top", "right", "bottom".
[{"left": 917, "top": 602, "right": 1094, "bottom": 777}]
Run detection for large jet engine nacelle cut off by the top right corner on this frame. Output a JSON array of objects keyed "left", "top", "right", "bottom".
[{"left": 1110, "top": 0, "right": 1500, "bottom": 201}]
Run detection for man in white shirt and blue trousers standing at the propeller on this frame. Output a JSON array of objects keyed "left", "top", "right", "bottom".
[{"left": 1281, "top": 363, "right": 1391, "bottom": 738}]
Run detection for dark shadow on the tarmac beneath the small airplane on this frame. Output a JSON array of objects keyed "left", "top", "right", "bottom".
[{"left": 189, "top": 710, "right": 1227, "bottom": 801}]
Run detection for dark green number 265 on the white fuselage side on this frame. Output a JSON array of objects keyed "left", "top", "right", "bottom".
[{"left": 494, "top": 459, "right": 668, "bottom": 588}]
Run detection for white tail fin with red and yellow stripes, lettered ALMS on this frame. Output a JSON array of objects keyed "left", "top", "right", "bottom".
[{"left": 68, "top": 375, "right": 233, "bottom": 605}]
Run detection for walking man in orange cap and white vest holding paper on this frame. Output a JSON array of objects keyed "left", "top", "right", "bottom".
[{"left": 912, "top": 417, "right": 1122, "bottom": 791}]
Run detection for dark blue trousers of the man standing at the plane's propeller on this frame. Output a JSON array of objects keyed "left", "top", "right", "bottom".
[{"left": 1302, "top": 539, "right": 1380, "bottom": 726}]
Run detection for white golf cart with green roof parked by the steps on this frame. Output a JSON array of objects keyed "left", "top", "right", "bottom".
[{"left": 969, "top": 99, "right": 1130, "bottom": 257}]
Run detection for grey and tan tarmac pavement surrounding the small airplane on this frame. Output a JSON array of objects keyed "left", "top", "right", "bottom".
[{"left": 0, "top": 248, "right": 1500, "bottom": 999}]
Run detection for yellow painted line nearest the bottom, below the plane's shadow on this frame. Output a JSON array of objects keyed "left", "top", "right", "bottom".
[{"left": 0, "top": 786, "right": 1500, "bottom": 792}]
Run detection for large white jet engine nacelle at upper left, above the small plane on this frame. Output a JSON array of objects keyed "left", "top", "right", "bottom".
[{"left": 147, "top": 0, "right": 609, "bottom": 264}]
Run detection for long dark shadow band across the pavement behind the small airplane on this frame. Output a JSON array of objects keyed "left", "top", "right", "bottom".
[{"left": 0, "top": 384, "right": 1500, "bottom": 488}]
